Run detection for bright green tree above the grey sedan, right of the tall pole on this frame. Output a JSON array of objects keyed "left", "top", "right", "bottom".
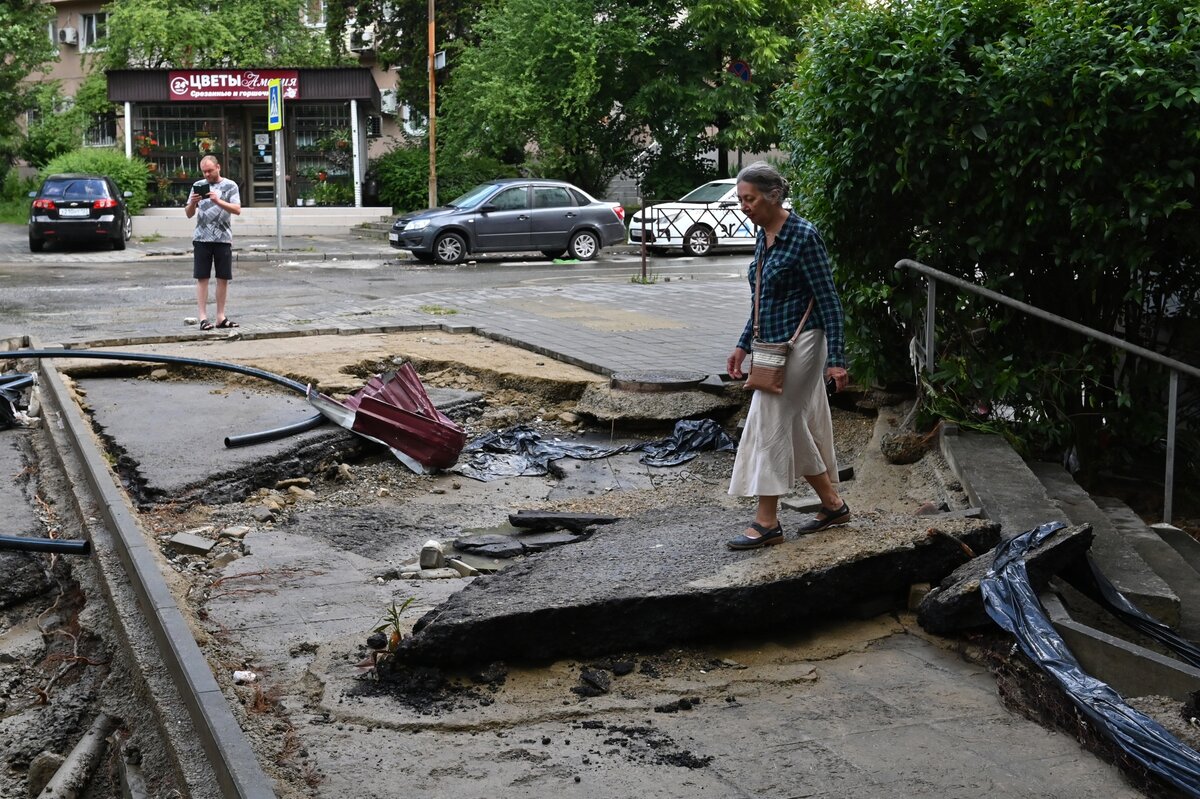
[{"left": 442, "top": 0, "right": 655, "bottom": 193}]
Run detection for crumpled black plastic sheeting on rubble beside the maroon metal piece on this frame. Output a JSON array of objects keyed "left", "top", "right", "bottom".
[{"left": 451, "top": 419, "right": 737, "bottom": 482}]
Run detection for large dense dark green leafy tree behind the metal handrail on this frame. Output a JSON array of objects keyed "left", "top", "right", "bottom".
[{"left": 781, "top": 0, "right": 1200, "bottom": 470}]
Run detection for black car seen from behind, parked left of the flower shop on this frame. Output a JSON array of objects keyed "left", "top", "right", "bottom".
[{"left": 29, "top": 174, "right": 133, "bottom": 252}]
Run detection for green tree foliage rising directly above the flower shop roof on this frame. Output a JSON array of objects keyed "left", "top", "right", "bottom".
[{"left": 97, "top": 0, "right": 344, "bottom": 70}]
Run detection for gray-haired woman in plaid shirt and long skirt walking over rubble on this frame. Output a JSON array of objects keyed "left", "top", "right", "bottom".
[{"left": 726, "top": 161, "right": 850, "bottom": 549}]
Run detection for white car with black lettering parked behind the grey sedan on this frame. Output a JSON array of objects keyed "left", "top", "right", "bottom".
[{"left": 629, "top": 178, "right": 755, "bottom": 256}]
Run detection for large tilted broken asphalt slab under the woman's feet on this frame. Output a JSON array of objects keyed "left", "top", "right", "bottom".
[{"left": 395, "top": 507, "right": 1000, "bottom": 666}]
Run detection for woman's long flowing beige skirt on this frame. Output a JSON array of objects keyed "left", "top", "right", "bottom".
[{"left": 730, "top": 330, "right": 838, "bottom": 497}]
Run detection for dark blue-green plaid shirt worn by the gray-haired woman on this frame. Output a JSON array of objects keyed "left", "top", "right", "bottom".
[{"left": 738, "top": 214, "right": 846, "bottom": 367}]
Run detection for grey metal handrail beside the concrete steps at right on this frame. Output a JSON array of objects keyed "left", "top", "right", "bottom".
[{"left": 895, "top": 258, "right": 1200, "bottom": 524}]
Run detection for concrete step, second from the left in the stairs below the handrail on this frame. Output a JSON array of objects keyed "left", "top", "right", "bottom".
[{"left": 1030, "top": 463, "right": 1180, "bottom": 627}]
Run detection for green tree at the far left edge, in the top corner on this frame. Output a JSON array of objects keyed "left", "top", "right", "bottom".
[{"left": 0, "top": 0, "right": 54, "bottom": 171}]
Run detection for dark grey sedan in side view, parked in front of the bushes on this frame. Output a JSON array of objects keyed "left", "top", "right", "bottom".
[{"left": 388, "top": 178, "right": 625, "bottom": 264}]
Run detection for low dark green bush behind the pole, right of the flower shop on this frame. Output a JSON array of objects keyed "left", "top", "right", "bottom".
[{"left": 371, "top": 145, "right": 517, "bottom": 212}]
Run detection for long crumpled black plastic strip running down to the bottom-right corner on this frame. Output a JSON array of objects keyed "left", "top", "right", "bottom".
[{"left": 980, "top": 522, "right": 1200, "bottom": 797}]
